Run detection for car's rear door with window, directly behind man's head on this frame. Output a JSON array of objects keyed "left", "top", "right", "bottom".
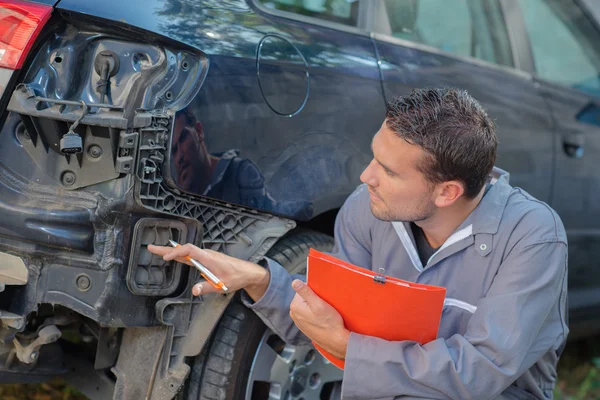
[{"left": 371, "top": 0, "right": 553, "bottom": 200}]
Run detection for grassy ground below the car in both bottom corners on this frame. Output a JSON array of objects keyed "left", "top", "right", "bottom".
[{"left": 0, "top": 337, "right": 600, "bottom": 400}]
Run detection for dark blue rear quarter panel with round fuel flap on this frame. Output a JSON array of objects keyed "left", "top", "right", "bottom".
[{"left": 162, "top": 0, "right": 385, "bottom": 220}]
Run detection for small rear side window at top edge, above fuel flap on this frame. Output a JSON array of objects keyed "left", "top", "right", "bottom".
[{"left": 258, "top": 0, "right": 358, "bottom": 26}]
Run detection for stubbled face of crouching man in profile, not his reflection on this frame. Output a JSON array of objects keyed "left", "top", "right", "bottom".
[{"left": 360, "top": 122, "right": 436, "bottom": 222}]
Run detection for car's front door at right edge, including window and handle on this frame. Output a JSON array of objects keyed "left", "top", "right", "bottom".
[{"left": 520, "top": 0, "right": 600, "bottom": 326}]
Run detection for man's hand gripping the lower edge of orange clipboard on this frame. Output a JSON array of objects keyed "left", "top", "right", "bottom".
[{"left": 290, "top": 279, "right": 350, "bottom": 360}]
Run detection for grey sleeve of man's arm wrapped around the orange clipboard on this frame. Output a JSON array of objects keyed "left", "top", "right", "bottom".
[{"left": 342, "top": 239, "right": 568, "bottom": 400}]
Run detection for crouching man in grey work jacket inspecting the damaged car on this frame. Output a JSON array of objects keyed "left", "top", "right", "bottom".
[{"left": 151, "top": 89, "right": 568, "bottom": 400}]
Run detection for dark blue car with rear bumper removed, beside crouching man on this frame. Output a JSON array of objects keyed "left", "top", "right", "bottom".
[{"left": 0, "top": 0, "right": 600, "bottom": 400}]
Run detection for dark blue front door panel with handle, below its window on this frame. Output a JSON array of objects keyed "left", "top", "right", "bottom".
[{"left": 540, "top": 82, "right": 600, "bottom": 291}]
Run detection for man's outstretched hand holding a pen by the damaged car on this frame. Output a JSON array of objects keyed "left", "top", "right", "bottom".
[{"left": 148, "top": 244, "right": 270, "bottom": 301}]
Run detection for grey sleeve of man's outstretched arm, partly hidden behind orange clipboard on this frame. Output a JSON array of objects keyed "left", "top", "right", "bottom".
[{"left": 241, "top": 186, "right": 373, "bottom": 345}]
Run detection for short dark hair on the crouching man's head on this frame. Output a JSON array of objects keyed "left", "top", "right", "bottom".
[{"left": 386, "top": 88, "right": 498, "bottom": 199}]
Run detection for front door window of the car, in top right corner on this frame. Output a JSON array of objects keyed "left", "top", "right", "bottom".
[{"left": 520, "top": 0, "right": 600, "bottom": 94}]
